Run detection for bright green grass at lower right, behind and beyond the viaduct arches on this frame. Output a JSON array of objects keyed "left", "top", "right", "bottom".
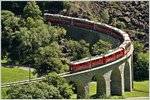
[{"left": 71, "top": 80, "right": 149, "bottom": 99}]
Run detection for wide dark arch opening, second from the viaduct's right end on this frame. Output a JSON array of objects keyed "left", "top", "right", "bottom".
[{"left": 110, "top": 68, "right": 122, "bottom": 95}]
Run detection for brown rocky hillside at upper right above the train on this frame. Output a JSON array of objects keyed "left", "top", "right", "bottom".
[{"left": 63, "top": 1, "right": 149, "bottom": 48}]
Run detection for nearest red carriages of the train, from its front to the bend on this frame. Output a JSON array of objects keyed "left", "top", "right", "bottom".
[{"left": 70, "top": 42, "right": 131, "bottom": 71}]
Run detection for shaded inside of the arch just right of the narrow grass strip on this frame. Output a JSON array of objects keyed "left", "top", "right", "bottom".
[{"left": 95, "top": 74, "right": 106, "bottom": 96}]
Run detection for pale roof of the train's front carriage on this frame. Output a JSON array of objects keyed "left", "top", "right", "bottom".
[{"left": 71, "top": 55, "right": 103, "bottom": 65}]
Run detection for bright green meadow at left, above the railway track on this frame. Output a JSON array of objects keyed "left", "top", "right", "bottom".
[{"left": 1, "top": 67, "right": 36, "bottom": 83}]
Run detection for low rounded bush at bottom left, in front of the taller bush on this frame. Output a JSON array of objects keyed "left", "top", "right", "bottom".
[{"left": 7, "top": 82, "right": 62, "bottom": 99}]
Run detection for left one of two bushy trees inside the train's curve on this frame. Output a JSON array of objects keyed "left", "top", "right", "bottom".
[{"left": 67, "top": 40, "right": 90, "bottom": 60}]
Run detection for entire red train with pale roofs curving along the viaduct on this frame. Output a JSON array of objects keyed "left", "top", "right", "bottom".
[{"left": 44, "top": 13, "right": 131, "bottom": 72}]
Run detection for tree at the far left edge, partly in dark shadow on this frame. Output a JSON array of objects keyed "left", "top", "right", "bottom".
[{"left": 1, "top": 10, "right": 20, "bottom": 58}]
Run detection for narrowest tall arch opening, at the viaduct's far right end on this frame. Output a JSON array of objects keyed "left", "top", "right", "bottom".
[{"left": 124, "top": 62, "right": 132, "bottom": 91}]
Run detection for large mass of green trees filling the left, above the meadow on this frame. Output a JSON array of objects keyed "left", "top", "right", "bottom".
[{"left": 2, "top": 1, "right": 69, "bottom": 75}]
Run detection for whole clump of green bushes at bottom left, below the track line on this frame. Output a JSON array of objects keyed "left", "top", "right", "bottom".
[{"left": 7, "top": 72, "right": 73, "bottom": 99}]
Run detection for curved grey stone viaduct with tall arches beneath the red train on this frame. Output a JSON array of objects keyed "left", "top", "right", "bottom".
[{"left": 45, "top": 14, "right": 134, "bottom": 98}]
